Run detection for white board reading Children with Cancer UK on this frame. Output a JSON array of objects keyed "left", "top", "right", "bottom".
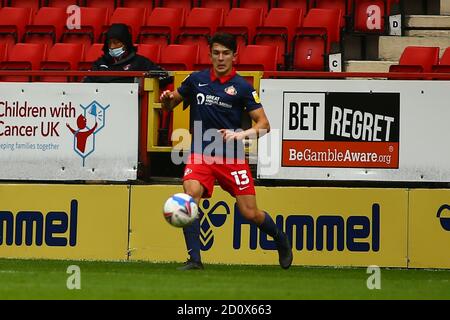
[{"left": 0, "top": 83, "right": 138, "bottom": 181}]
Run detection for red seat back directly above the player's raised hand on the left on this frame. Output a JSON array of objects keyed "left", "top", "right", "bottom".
[{"left": 160, "top": 44, "right": 199, "bottom": 71}]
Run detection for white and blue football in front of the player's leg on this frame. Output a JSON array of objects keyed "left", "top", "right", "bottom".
[{"left": 163, "top": 193, "right": 198, "bottom": 228}]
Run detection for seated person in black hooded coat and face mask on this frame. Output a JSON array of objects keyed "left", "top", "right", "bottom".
[{"left": 83, "top": 23, "right": 172, "bottom": 87}]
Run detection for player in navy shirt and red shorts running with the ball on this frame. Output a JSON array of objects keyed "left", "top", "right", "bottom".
[{"left": 160, "top": 33, "right": 293, "bottom": 270}]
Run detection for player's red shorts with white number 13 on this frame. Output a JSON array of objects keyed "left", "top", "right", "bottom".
[{"left": 183, "top": 154, "right": 255, "bottom": 198}]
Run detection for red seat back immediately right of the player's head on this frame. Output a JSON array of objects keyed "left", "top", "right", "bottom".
[{"left": 236, "top": 45, "right": 278, "bottom": 71}]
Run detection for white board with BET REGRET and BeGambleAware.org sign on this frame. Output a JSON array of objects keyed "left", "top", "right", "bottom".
[{"left": 258, "top": 79, "right": 450, "bottom": 182}]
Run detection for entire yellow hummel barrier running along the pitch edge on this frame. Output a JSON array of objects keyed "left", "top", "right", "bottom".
[{"left": 0, "top": 184, "right": 450, "bottom": 268}]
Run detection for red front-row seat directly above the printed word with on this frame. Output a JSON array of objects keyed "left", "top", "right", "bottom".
[{"left": 40, "top": 43, "right": 84, "bottom": 82}]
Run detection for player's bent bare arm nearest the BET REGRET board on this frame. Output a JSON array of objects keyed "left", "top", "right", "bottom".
[{"left": 219, "top": 108, "right": 270, "bottom": 140}]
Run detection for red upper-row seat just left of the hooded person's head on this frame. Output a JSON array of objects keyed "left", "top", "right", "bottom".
[{"left": 61, "top": 7, "right": 109, "bottom": 46}]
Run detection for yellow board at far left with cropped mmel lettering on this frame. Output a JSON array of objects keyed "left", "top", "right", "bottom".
[{"left": 0, "top": 184, "right": 130, "bottom": 260}]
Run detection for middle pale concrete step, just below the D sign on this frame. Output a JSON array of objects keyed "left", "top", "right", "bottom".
[{"left": 378, "top": 36, "right": 450, "bottom": 61}]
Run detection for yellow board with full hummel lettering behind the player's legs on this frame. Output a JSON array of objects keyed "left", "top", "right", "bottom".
[{"left": 130, "top": 186, "right": 408, "bottom": 267}]
